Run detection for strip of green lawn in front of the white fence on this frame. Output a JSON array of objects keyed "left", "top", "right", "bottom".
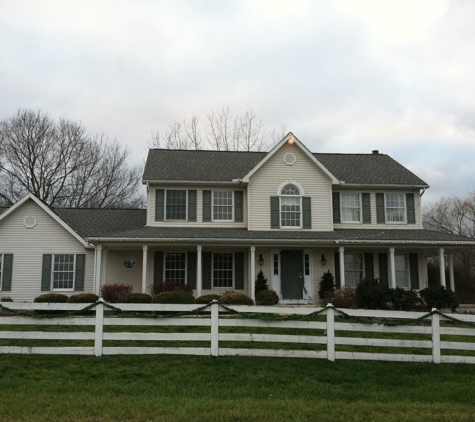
[{"left": 0, "top": 355, "right": 475, "bottom": 422}]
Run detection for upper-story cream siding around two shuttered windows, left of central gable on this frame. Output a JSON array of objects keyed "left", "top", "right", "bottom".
[{"left": 148, "top": 184, "right": 247, "bottom": 227}]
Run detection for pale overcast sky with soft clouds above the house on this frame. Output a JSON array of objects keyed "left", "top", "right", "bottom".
[{"left": 0, "top": 0, "right": 475, "bottom": 202}]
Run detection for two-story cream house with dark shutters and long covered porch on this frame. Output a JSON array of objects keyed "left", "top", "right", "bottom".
[{"left": 0, "top": 133, "right": 475, "bottom": 304}]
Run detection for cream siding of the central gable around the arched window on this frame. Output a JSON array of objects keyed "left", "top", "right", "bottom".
[{"left": 248, "top": 144, "right": 333, "bottom": 231}]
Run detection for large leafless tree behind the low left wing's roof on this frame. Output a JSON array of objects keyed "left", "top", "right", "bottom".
[{"left": 0, "top": 110, "right": 142, "bottom": 207}]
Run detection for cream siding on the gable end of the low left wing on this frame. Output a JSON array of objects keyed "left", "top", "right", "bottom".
[{"left": 0, "top": 200, "right": 94, "bottom": 302}]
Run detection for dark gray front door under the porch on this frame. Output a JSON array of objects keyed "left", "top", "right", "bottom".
[{"left": 280, "top": 250, "right": 303, "bottom": 300}]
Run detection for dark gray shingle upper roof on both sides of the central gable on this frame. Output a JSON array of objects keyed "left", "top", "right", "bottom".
[{"left": 143, "top": 149, "right": 428, "bottom": 186}]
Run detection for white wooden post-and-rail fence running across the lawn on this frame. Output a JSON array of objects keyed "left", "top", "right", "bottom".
[{"left": 0, "top": 301, "right": 475, "bottom": 363}]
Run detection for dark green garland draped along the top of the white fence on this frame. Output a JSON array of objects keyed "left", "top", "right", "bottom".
[{"left": 0, "top": 299, "right": 475, "bottom": 327}]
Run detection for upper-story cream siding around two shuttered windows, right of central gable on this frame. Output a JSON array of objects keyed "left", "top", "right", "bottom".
[{"left": 333, "top": 187, "right": 422, "bottom": 229}]
